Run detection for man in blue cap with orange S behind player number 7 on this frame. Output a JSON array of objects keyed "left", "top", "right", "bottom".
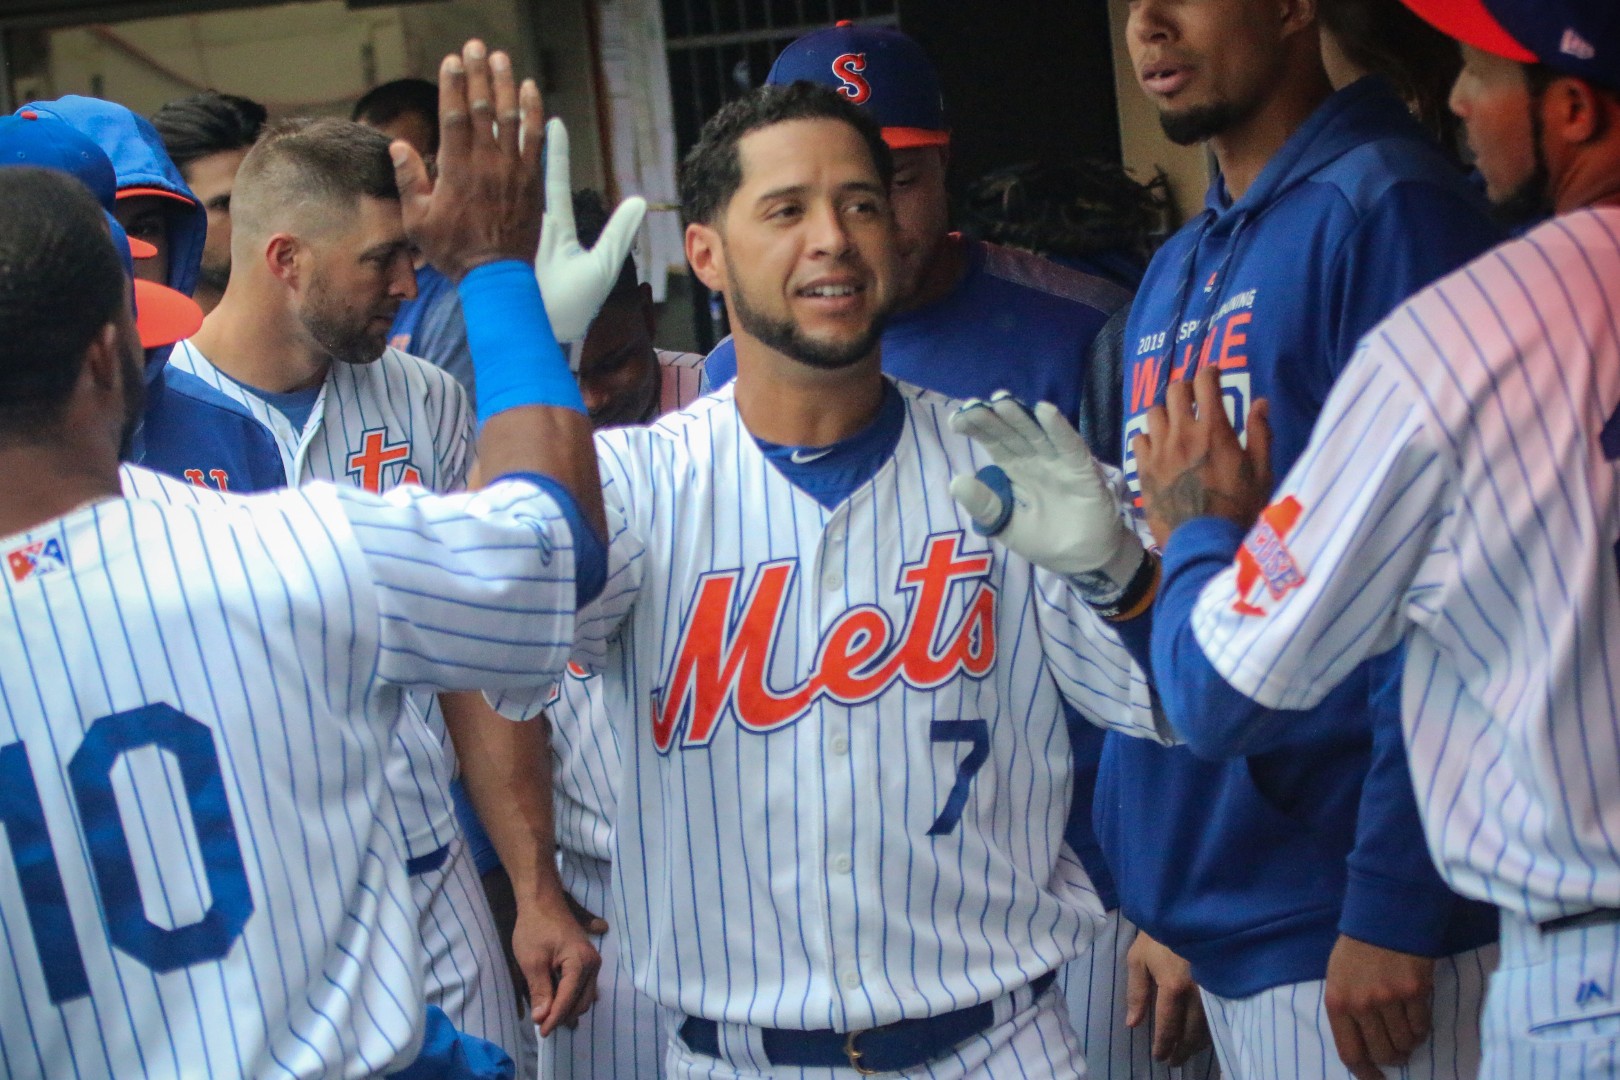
[{"left": 705, "top": 23, "right": 1192, "bottom": 1080}]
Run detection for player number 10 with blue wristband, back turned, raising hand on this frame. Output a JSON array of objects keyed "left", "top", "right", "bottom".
[{"left": 0, "top": 35, "right": 604, "bottom": 1077}]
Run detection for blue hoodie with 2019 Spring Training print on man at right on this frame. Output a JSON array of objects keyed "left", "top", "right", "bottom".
[{"left": 1094, "top": 79, "right": 1499, "bottom": 997}]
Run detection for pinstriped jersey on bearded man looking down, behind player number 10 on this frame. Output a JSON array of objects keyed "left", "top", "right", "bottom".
[{"left": 170, "top": 342, "right": 475, "bottom": 858}]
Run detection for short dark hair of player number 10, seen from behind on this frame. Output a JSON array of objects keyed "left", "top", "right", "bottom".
[{"left": 0, "top": 167, "right": 130, "bottom": 440}]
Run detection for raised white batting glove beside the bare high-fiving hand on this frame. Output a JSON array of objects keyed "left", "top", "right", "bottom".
[{"left": 535, "top": 120, "right": 646, "bottom": 351}]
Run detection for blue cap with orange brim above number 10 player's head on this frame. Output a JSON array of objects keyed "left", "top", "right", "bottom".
[{"left": 0, "top": 108, "right": 203, "bottom": 348}]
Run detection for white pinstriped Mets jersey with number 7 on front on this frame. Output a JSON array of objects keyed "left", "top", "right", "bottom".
[{"left": 496, "top": 387, "right": 1157, "bottom": 1030}]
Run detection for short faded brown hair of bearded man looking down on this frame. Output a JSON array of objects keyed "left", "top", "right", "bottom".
[{"left": 230, "top": 118, "right": 400, "bottom": 233}]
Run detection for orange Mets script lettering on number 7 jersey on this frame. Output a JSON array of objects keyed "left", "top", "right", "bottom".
[{"left": 653, "top": 533, "right": 996, "bottom": 751}]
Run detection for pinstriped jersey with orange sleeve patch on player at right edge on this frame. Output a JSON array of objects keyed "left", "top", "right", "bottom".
[{"left": 1192, "top": 209, "right": 1620, "bottom": 920}]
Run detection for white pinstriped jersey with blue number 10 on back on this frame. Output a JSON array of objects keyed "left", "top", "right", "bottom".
[{"left": 0, "top": 470, "right": 573, "bottom": 1077}]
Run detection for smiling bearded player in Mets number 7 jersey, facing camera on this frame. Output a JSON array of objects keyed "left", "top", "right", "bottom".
[{"left": 496, "top": 84, "right": 1185, "bottom": 1080}]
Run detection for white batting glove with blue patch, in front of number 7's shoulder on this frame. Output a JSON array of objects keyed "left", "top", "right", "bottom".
[{"left": 951, "top": 390, "right": 1145, "bottom": 589}]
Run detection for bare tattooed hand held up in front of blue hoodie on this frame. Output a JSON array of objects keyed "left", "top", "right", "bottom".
[{"left": 1131, "top": 364, "right": 1272, "bottom": 547}]
